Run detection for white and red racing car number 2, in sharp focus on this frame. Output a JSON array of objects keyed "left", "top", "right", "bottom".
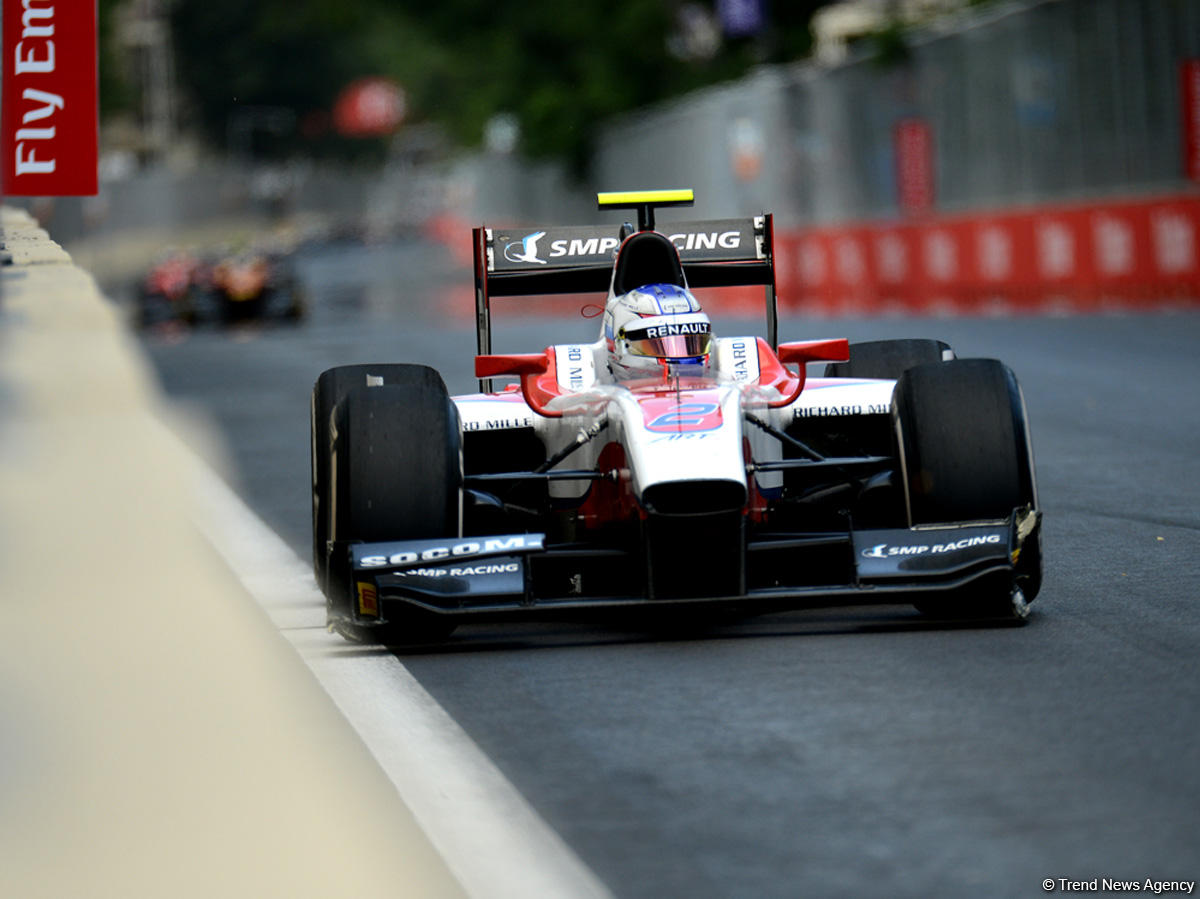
[{"left": 311, "top": 191, "right": 1042, "bottom": 645}]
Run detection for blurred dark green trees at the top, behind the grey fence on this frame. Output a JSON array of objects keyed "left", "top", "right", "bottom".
[{"left": 172, "top": 0, "right": 822, "bottom": 163}]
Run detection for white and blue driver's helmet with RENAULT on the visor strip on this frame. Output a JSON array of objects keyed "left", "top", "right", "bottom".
[{"left": 605, "top": 284, "right": 713, "bottom": 378}]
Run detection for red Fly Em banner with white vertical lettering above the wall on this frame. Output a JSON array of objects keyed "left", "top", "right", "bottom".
[{"left": 0, "top": 0, "right": 98, "bottom": 197}]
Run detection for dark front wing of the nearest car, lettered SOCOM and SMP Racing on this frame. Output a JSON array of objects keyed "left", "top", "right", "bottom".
[{"left": 348, "top": 511, "right": 1039, "bottom": 625}]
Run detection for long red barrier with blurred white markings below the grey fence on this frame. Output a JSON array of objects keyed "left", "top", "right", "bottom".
[{"left": 775, "top": 194, "right": 1200, "bottom": 314}]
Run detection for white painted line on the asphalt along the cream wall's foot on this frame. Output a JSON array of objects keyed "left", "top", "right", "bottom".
[{"left": 177, "top": 432, "right": 612, "bottom": 899}]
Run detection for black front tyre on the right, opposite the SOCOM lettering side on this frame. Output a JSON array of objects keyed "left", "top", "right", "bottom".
[{"left": 893, "top": 359, "right": 1042, "bottom": 621}]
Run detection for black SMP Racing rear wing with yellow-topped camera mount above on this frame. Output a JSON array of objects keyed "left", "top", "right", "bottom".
[{"left": 472, "top": 191, "right": 779, "bottom": 390}]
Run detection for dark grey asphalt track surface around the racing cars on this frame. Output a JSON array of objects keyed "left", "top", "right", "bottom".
[{"left": 138, "top": 244, "right": 1200, "bottom": 898}]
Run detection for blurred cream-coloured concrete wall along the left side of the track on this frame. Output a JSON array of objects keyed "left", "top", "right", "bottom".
[{"left": 0, "top": 208, "right": 462, "bottom": 899}]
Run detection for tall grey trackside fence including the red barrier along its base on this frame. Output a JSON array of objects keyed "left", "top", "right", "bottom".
[{"left": 595, "top": 0, "right": 1200, "bottom": 313}]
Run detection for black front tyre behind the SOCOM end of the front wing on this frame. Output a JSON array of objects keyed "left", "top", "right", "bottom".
[{"left": 326, "top": 366, "right": 462, "bottom": 645}]
